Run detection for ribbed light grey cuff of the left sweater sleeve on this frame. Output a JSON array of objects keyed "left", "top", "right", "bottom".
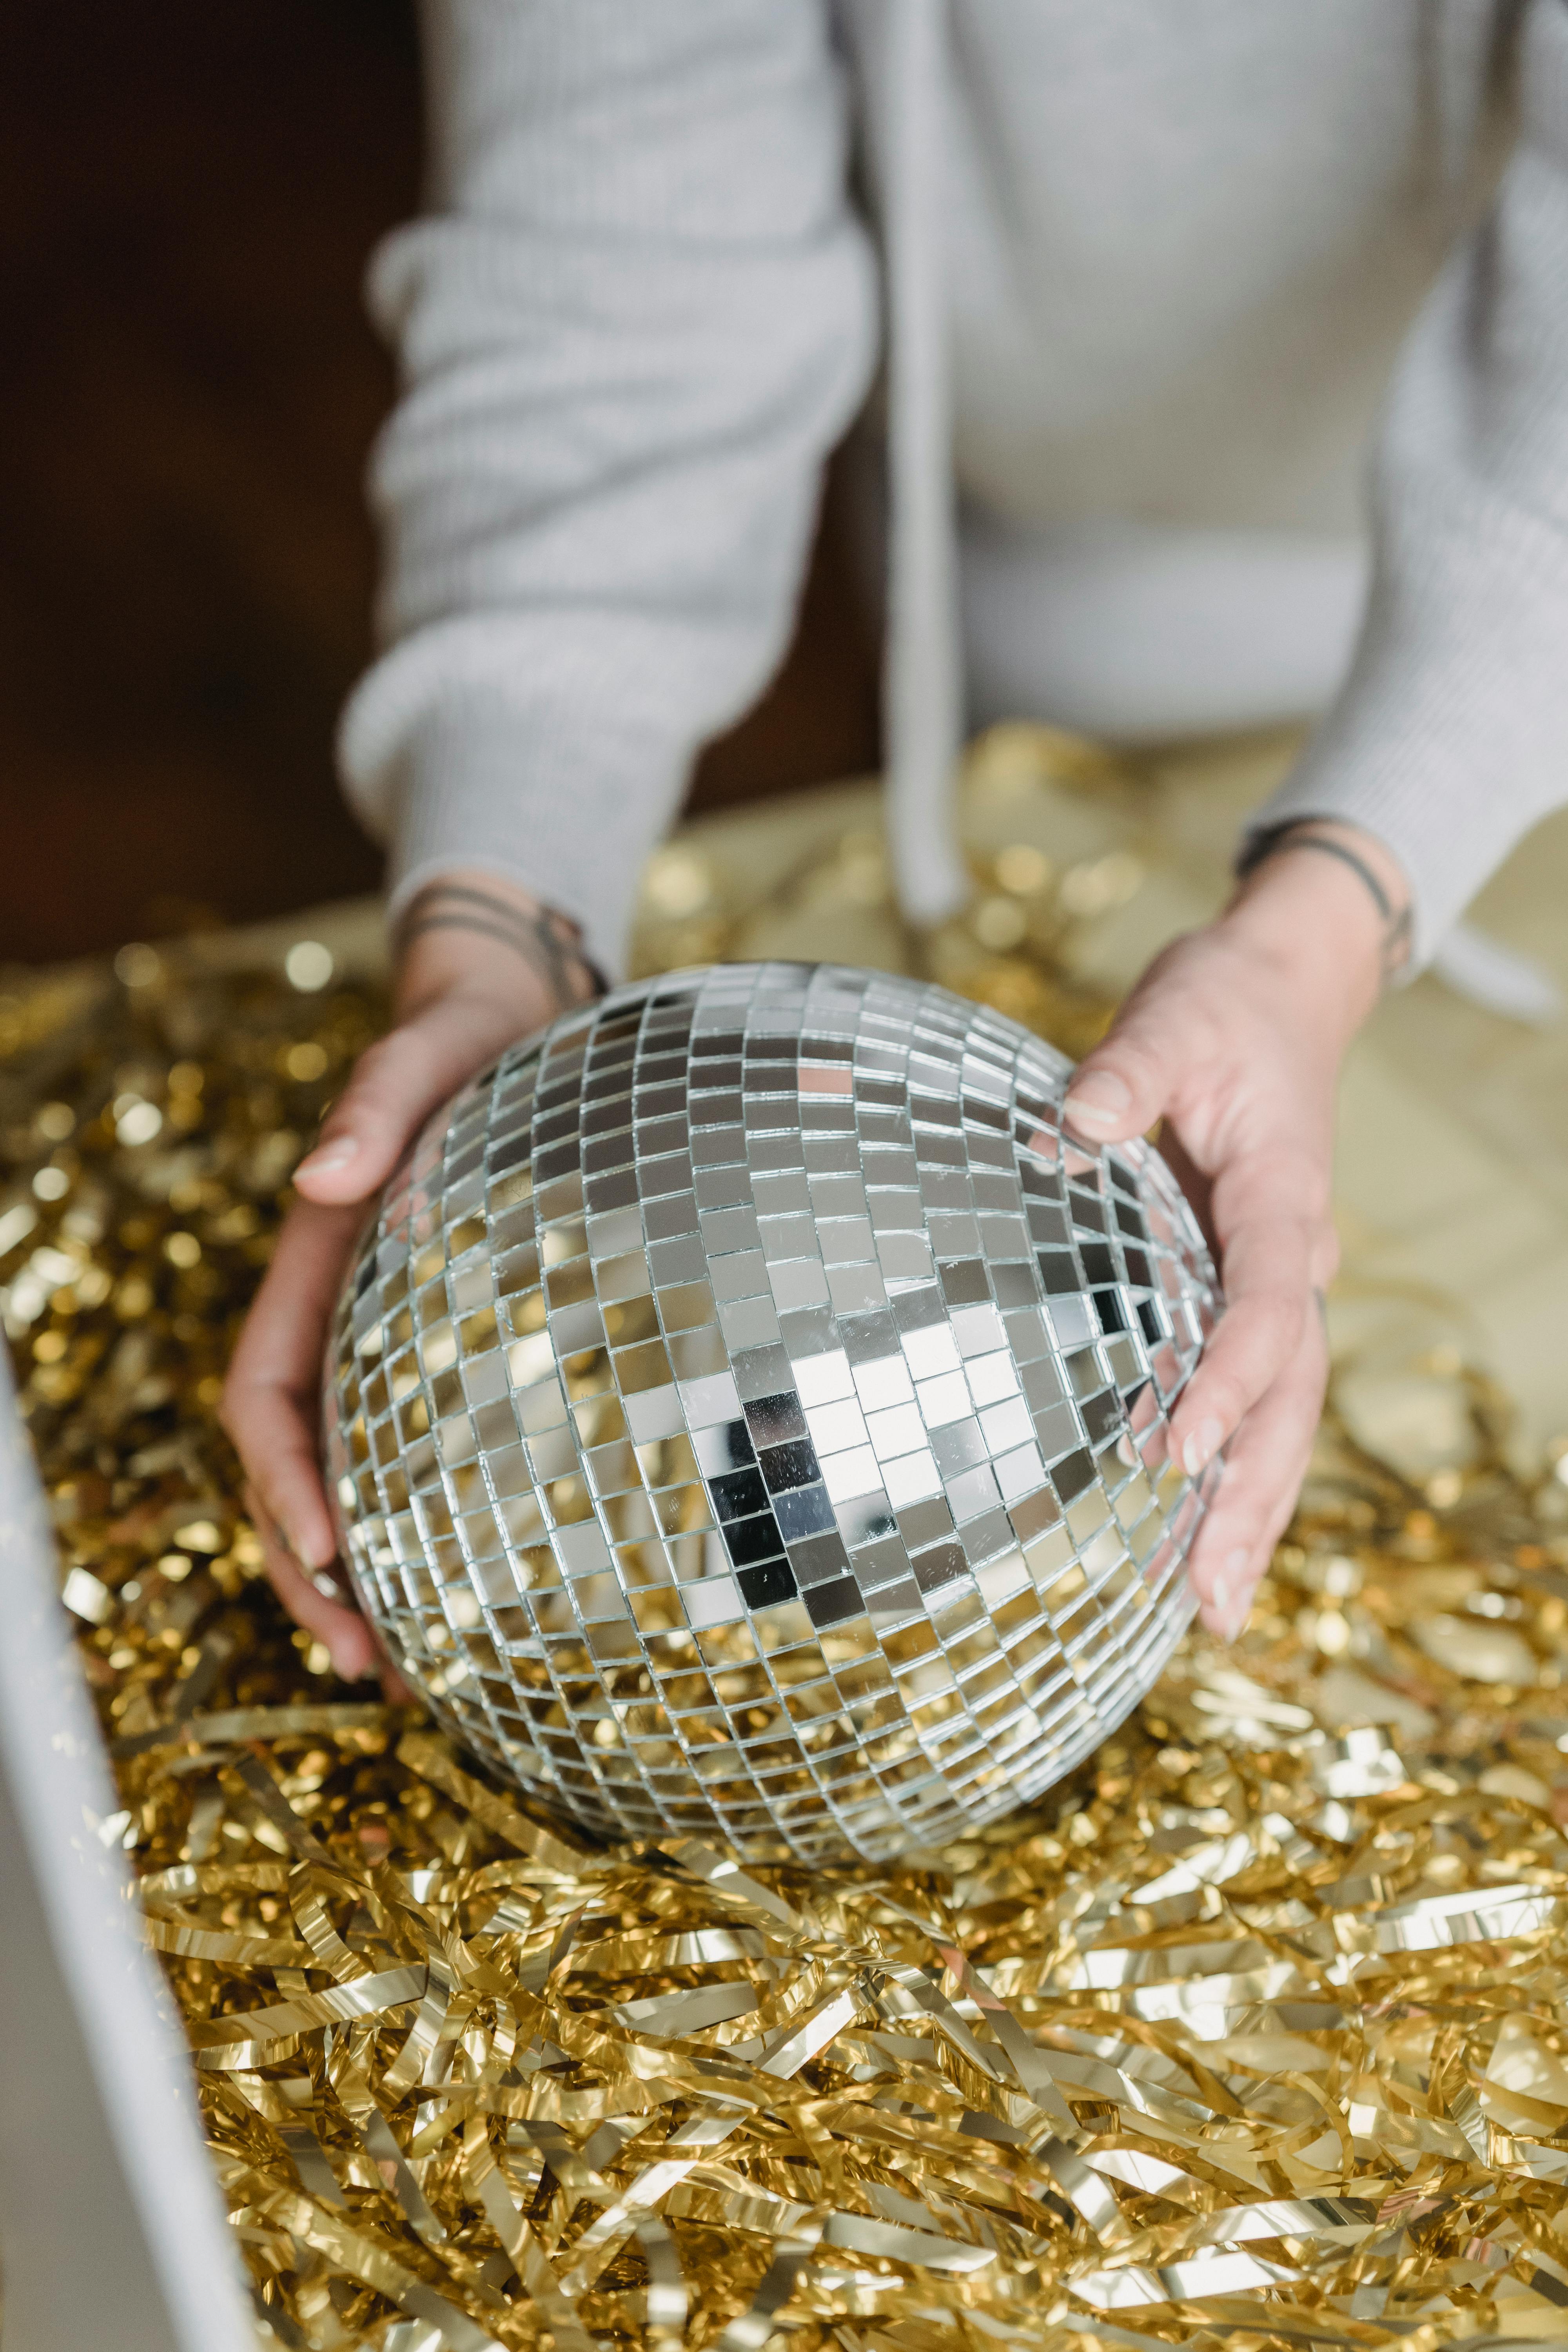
[{"left": 369, "top": 694, "right": 686, "bottom": 981}]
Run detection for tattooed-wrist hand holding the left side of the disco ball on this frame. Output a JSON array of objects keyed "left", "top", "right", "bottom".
[{"left": 223, "top": 873, "right": 597, "bottom": 1682}]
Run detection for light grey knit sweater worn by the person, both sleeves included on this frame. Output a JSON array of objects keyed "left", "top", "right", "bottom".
[{"left": 341, "top": 0, "right": 1568, "bottom": 969}]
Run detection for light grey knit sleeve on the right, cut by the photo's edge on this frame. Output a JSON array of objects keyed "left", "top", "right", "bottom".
[{"left": 1248, "top": 0, "right": 1568, "bottom": 962}]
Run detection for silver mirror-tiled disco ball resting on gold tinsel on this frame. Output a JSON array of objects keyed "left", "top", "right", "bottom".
[{"left": 327, "top": 964, "right": 1218, "bottom": 1860}]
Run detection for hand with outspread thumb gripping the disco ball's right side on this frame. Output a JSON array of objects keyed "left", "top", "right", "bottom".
[{"left": 1067, "top": 823, "right": 1406, "bottom": 1642}]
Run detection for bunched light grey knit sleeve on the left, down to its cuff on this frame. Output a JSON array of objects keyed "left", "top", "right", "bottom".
[{"left": 339, "top": 0, "right": 877, "bottom": 971}]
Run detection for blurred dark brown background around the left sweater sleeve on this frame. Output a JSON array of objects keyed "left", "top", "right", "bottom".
[{"left": 0, "top": 0, "right": 875, "bottom": 962}]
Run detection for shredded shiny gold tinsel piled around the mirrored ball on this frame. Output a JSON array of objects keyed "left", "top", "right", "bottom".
[{"left": 0, "top": 786, "right": 1568, "bottom": 2352}]
